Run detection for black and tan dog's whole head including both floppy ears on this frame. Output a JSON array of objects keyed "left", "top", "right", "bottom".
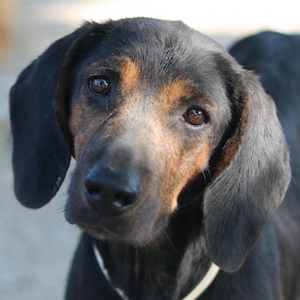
[{"left": 11, "top": 18, "right": 290, "bottom": 271}]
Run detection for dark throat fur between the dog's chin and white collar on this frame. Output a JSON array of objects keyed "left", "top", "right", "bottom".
[{"left": 95, "top": 203, "right": 211, "bottom": 300}]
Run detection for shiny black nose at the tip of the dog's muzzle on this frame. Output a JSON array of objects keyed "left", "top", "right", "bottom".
[{"left": 84, "top": 164, "right": 141, "bottom": 213}]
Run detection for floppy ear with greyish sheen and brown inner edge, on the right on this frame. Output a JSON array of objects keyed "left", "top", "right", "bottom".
[{"left": 203, "top": 70, "right": 290, "bottom": 272}]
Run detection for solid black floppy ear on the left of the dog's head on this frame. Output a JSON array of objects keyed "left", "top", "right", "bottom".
[{"left": 10, "top": 23, "right": 97, "bottom": 208}]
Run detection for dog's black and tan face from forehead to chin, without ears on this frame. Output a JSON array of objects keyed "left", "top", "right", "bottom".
[{"left": 62, "top": 24, "right": 231, "bottom": 245}]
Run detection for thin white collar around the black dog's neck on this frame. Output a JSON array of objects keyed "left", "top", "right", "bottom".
[{"left": 93, "top": 244, "right": 220, "bottom": 300}]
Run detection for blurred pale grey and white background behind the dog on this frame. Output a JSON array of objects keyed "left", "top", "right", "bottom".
[{"left": 0, "top": 0, "right": 300, "bottom": 300}]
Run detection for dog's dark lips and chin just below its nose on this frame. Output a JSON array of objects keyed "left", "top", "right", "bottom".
[{"left": 65, "top": 192, "right": 169, "bottom": 247}]
